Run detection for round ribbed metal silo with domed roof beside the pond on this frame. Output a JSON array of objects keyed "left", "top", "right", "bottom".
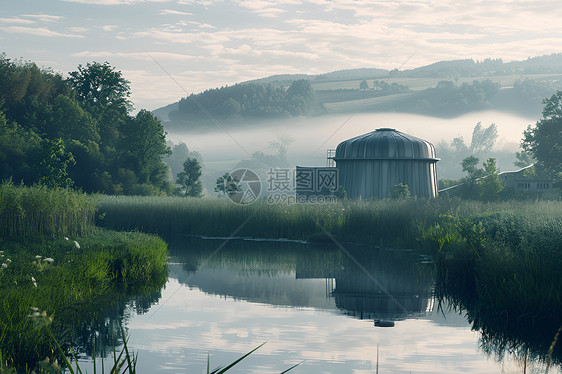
[{"left": 334, "top": 128, "right": 439, "bottom": 199}]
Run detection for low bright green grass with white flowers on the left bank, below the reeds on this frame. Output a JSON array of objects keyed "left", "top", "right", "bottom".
[{"left": 0, "top": 230, "right": 167, "bottom": 368}]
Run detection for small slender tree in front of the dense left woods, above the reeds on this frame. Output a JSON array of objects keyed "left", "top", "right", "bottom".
[{"left": 39, "top": 139, "right": 76, "bottom": 188}]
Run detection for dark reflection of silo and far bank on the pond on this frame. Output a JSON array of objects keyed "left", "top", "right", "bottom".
[{"left": 166, "top": 237, "right": 435, "bottom": 320}]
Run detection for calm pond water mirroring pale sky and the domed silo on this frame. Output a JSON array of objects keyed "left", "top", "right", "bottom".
[{"left": 77, "top": 236, "right": 559, "bottom": 374}]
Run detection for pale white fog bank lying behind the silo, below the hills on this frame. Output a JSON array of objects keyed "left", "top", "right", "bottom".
[{"left": 168, "top": 111, "right": 537, "bottom": 182}]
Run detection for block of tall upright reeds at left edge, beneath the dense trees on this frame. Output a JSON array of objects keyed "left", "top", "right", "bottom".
[{"left": 0, "top": 181, "right": 96, "bottom": 237}]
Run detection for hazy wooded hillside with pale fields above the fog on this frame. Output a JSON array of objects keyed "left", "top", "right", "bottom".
[{"left": 154, "top": 54, "right": 562, "bottom": 131}]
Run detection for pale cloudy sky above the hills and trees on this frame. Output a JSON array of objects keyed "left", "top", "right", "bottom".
[{"left": 0, "top": 0, "right": 562, "bottom": 110}]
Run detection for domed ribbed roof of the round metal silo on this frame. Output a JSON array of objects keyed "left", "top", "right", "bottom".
[{"left": 334, "top": 128, "right": 437, "bottom": 161}]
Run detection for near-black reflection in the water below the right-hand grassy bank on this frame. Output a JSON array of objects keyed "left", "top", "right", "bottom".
[{"left": 436, "top": 254, "right": 562, "bottom": 366}]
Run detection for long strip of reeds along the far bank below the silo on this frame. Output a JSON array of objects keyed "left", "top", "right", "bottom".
[{"left": 99, "top": 196, "right": 562, "bottom": 248}]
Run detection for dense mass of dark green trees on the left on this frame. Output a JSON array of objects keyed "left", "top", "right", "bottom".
[{"left": 0, "top": 54, "right": 175, "bottom": 195}]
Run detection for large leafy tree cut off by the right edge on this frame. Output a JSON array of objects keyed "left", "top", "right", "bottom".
[{"left": 521, "top": 91, "right": 562, "bottom": 180}]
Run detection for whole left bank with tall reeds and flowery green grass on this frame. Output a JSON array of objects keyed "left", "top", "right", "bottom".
[{"left": 0, "top": 183, "right": 167, "bottom": 370}]
